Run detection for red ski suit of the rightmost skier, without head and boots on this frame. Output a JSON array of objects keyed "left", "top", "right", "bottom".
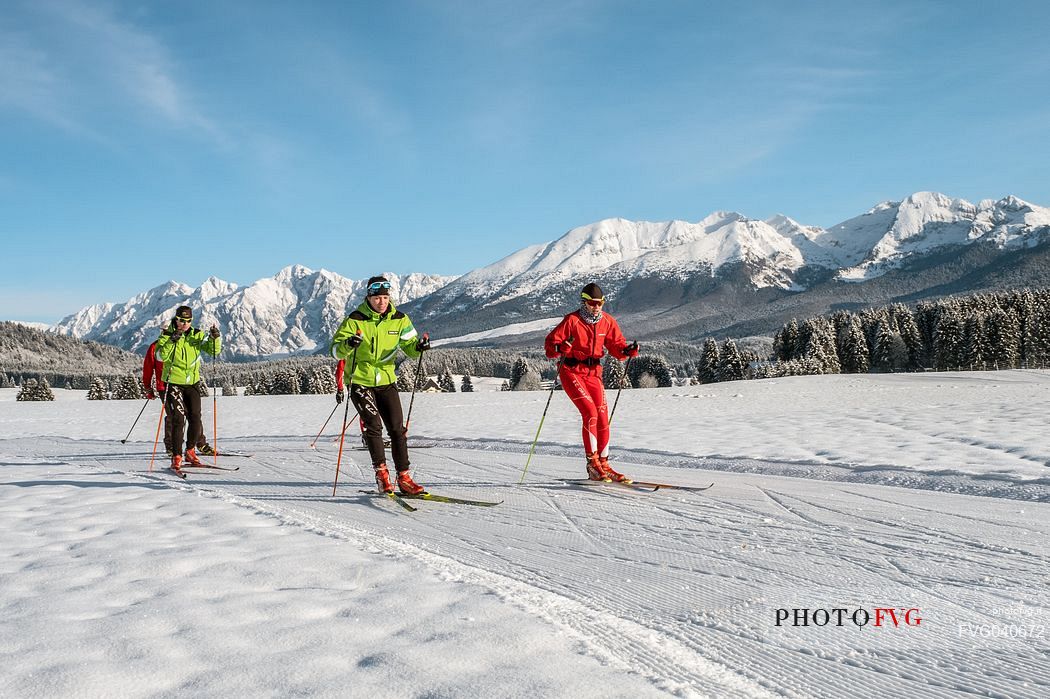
[{"left": 544, "top": 311, "right": 627, "bottom": 457}]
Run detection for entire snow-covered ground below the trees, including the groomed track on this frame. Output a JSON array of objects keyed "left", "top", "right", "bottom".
[{"left": 0, "top": 372, "right": 1050, "bottom": 697}]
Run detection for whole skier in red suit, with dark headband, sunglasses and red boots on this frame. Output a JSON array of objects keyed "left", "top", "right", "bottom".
[{"left": 544, "top": 282, "right": 638, "bottom": 483}]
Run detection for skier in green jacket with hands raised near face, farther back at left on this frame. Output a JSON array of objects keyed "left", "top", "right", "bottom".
[{"left": 154, "top": 305, "right": 222, "bottom": 475}]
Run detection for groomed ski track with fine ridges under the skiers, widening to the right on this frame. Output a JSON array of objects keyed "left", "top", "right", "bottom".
[{"left": 15, "top": 437, "right": 1050, "bottom": 697}]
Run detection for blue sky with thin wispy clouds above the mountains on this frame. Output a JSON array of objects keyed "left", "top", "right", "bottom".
[{"left": 0, "top": 0, "right": 1050, "bottom": 322}]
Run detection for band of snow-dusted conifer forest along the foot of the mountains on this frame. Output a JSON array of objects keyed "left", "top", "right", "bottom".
[{"left": 10, "top": 289, "right": 1050, "bottom": 400}]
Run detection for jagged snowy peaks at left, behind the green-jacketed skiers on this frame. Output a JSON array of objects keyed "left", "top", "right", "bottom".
[{"left": 55, "top": 264, "right": 455, "bottom": 357}]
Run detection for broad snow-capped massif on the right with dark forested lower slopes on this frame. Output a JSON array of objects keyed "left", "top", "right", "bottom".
[{"left": 406, "top": 192, "right": 1050, "bottom": 337}]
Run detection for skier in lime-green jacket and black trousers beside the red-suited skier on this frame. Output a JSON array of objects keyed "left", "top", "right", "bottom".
[{"left": 332, "top": 277, "right": 431, "bottom": 495}]
